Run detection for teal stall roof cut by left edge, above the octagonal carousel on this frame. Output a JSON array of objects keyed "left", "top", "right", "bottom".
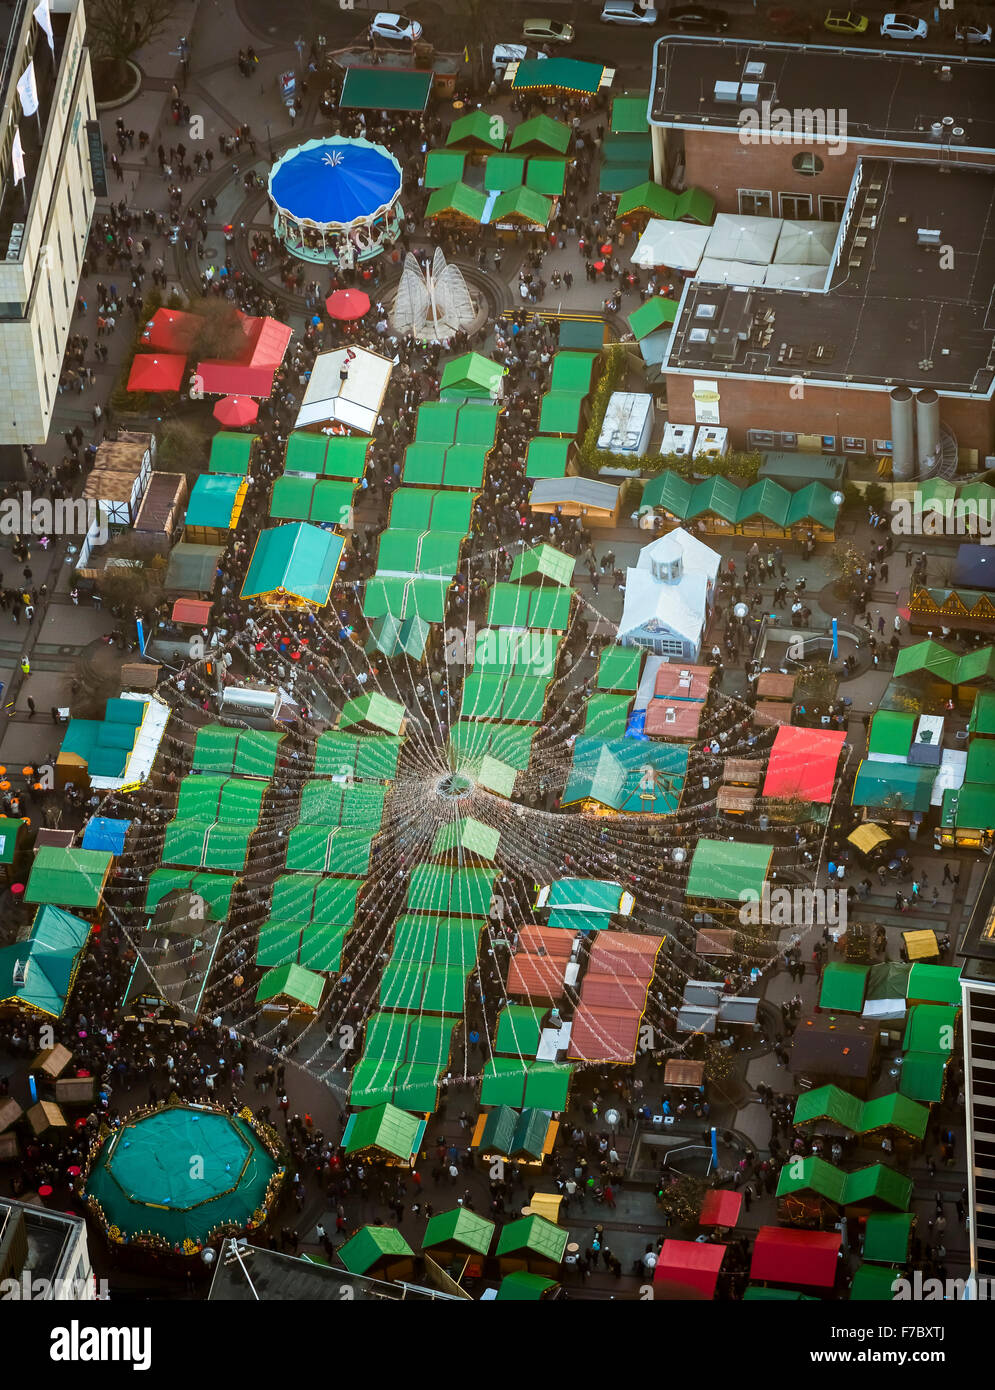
[{"left": 0, "top": 904, "right": 92, "bottom": 1019}]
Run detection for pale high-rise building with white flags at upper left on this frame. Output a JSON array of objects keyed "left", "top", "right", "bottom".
[{"left": 0, "top": 0, "right": 103, "bottom": 445}]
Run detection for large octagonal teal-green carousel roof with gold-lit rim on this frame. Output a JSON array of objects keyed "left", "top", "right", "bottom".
[{"left": 83, "top": 1105, "right": 283, "bottom": 1255}]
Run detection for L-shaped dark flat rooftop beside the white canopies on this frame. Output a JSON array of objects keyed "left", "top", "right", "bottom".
[{"left": 664, "top": 160, "right": 995, "bottom": 396}]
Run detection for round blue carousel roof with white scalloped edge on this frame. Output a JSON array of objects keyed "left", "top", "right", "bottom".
[{"left": 270, "top": 138, "right": 400, "bottom": 225}]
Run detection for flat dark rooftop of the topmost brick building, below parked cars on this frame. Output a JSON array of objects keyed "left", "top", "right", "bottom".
[{"left": 649, "top": 36, "right": 995, "bottom": 152}]
